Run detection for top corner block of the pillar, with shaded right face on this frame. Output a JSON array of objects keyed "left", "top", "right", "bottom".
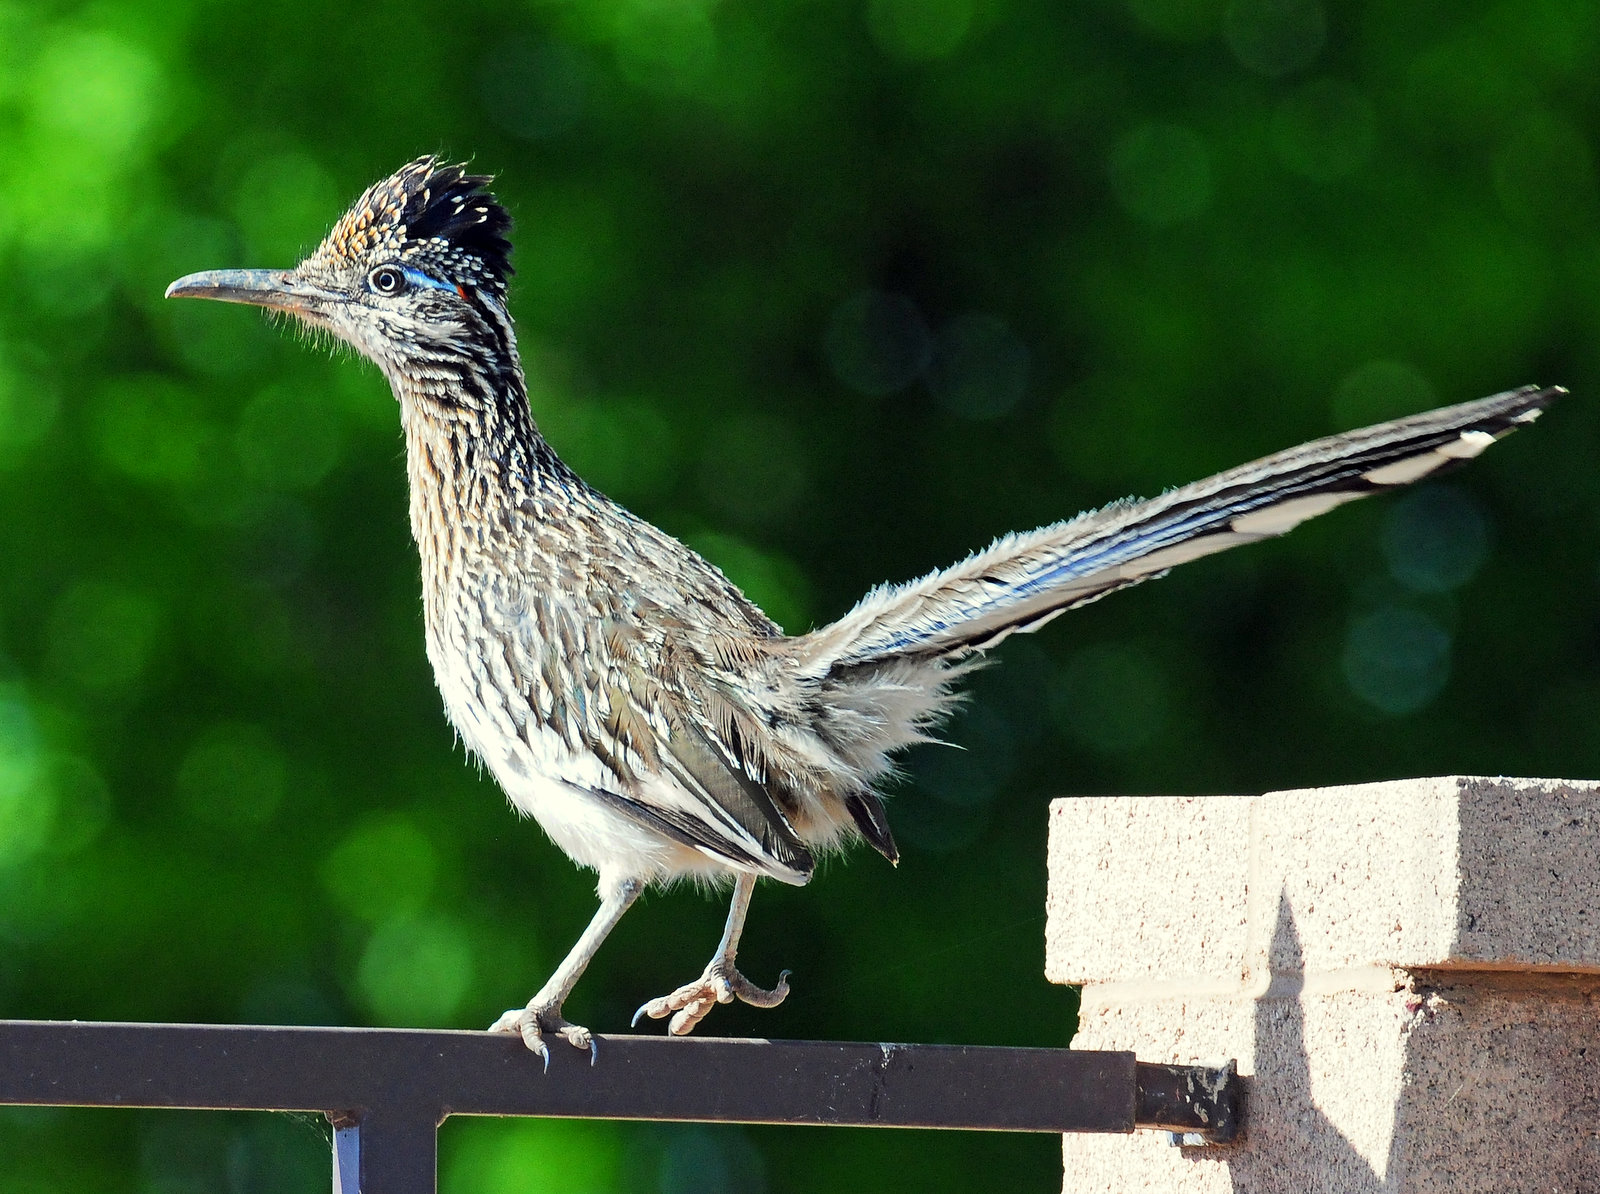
[{"left": 1251, "top": 776, "right": 1600, "bottom": 973}]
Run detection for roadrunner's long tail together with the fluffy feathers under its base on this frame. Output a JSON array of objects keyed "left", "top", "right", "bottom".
[{"left": 787, "top": 386, "right": 1566, "bottom": 859}]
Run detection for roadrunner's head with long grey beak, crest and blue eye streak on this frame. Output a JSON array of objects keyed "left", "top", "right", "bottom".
[{"left": 166, "top": 157, "right": 515, "bottom": 391}]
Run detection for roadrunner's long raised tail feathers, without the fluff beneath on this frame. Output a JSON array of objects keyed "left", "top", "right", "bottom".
[{"left": 797, "top": 386, "right": 1566, "bottom": 682}]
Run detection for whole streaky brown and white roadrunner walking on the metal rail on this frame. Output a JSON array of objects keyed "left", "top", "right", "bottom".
[{"left": 166, "top": 157, "right": 1563, "bottom": 1064}]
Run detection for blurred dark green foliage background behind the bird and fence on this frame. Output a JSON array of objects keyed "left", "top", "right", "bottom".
[{"left": 0, "top": 0, "right": 1600, "bottom": 1194}]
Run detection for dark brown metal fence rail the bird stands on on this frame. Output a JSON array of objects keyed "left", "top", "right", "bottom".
[{"left": 0, "top": 1020, "right": 1238, "bottom": 1194}]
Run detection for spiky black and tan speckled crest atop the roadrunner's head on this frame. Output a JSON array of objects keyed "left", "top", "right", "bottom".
[{"left": 314, "top": 155, "right": 512, "bottom": 293}]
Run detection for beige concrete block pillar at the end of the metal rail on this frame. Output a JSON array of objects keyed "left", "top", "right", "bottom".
[{"left": 1046, "top": 776, "right": 1600, "bottom": 1194}]
